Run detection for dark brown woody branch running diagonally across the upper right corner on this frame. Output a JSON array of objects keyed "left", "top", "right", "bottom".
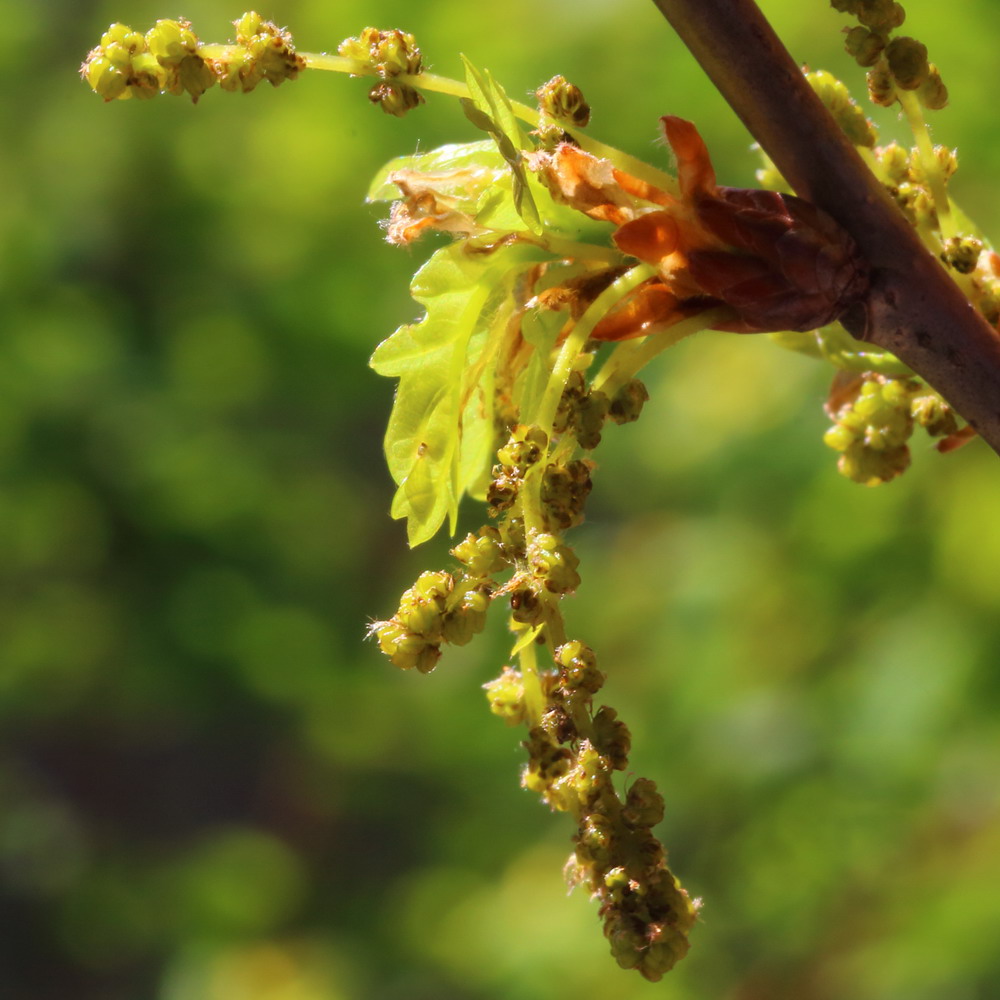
[{"left": 654, "top": 0, "right": 1000, "bottom": 454}]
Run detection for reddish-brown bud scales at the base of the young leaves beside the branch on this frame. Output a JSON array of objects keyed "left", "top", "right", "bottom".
[{"left": 594, "top": 115, "right": 868, "bottom": 340}]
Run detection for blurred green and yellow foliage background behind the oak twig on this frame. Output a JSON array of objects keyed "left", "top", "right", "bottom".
[{"left": 0, "top": 0, "right": 1000, "bottom": 1000}]
